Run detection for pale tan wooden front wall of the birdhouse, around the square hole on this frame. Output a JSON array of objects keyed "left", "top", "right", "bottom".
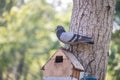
[{"left": 44, "top": 49, "right": 73, "bottom": 77}]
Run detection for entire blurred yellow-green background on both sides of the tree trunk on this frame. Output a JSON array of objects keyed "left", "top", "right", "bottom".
[{"left": 0, "top": 0, "right": 120, "bottom": 80}]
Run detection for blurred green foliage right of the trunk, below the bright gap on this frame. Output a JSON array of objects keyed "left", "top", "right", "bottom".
[{"left": 108, "top": 30, "right": 120, "bottom": 80}]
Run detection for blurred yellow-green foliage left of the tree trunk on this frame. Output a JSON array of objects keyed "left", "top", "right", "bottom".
[{"left": 0, "top": 0, "right": 70, "bottom": 80}]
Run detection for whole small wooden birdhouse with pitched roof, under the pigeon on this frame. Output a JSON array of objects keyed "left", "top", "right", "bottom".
[{"left": 42, "top": 49, "right": 84, "bottom": 80}]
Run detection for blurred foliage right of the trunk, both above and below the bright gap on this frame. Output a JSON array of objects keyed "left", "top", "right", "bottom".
[{"left": 107, "top": 0, "right": 120, "bottom": 80}]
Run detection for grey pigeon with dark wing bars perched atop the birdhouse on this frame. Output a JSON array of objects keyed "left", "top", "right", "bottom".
[{"left": 56, "top": 25, "right": 94, "bottom": 45}]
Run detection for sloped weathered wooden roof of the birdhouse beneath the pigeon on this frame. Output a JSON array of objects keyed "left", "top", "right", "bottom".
[{"left": 41, "top": 48, "right": 84, "bottom": 71}]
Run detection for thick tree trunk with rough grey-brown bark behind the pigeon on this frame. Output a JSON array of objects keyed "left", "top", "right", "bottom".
[{"left": 70, "top": 0, "right": 115, "bottom": 80}]
